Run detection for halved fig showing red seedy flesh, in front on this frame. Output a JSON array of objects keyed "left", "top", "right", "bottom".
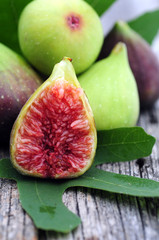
[{"left": 10, "top": 57, "right": 97, "bottom": 178}]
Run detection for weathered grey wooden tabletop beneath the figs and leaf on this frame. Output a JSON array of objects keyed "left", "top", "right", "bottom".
[{"left": 0, "top": 101, "right": 159, "bottom": 240}]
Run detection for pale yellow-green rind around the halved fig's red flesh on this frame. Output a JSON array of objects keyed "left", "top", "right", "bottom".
[{"left": 10, "top": 57, "right": 97, "bottom": 179}]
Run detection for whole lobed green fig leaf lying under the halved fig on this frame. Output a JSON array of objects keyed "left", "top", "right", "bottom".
[{"left": 0, "top": 127, "right": 159, "bottom": 233}]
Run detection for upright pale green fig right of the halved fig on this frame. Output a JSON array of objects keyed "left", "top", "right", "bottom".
[{"left": 79, "top": 43, "right": 139, "bottom": 130}]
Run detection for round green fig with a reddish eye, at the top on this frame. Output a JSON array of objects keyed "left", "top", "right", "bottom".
[{"left": 18, "top": 0, "right": 104, "bottom": 75}]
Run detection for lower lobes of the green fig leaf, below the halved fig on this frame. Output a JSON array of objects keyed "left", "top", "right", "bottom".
[{"left": 0, "top": 156, "right": 159, "bottom": 233}]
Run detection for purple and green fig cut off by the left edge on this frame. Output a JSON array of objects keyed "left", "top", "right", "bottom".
[{"left": 0, "top": 43, "right": 42, "bottom": 144}]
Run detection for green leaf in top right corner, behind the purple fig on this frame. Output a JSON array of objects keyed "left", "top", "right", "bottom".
[{"left": 129, "top": 10, "right": 159, "bottom": 44}]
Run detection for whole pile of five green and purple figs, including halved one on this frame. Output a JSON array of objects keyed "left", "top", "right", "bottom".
[{"left": 0, "top": 0, "right": 159, "bottom": 178}]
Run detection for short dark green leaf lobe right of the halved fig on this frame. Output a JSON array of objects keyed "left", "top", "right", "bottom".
[{"left": 95, "top": 127, "right": 155, "bottom": 165}]
